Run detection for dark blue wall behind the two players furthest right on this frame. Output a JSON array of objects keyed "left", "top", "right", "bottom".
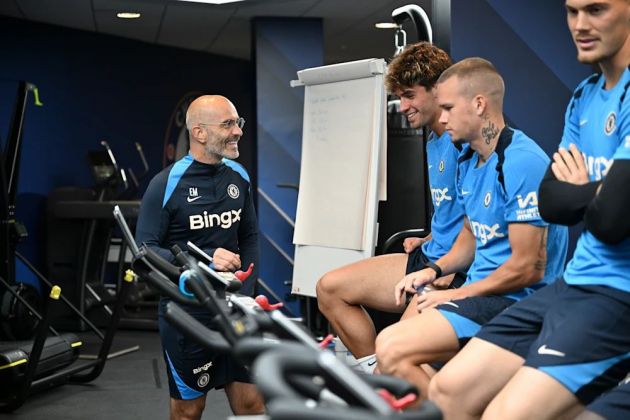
[{"left": 451, "top": 0, "right": 592, "bottom": 254}]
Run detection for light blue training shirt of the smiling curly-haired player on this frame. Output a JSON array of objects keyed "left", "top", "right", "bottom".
[{"left": 422, "top": 132, "right": 464, "bottom": 262}]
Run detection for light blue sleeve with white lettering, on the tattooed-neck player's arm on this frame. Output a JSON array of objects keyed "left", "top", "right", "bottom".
[{"left": 503, "top": 148, "right": 548, "bottom": 226}]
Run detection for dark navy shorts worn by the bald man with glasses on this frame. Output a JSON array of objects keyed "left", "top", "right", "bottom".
[{"left": 158, "top": 299, "right": 251, "bottom": 400}]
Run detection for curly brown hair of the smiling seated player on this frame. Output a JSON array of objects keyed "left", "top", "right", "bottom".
[{"left": 385, "top": 42, "right": 453, "bottom": 93}]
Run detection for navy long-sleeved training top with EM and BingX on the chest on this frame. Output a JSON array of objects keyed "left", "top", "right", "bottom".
[{"left": 136, "top": 155, "right": 258, "bottom": 294}]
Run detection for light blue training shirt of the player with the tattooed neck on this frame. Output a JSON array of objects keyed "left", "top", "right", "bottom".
[{"left": 458, "top": 127, "right": 568, "bottom": 300}]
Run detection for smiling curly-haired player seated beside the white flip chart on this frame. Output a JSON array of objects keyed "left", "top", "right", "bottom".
[{"left": 317, "top": 42, "right": 465, "bottom": 372}]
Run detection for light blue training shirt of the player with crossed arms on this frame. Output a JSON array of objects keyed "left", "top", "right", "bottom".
[{"left": 560, "top": 68, "right": 630, "bottom": 292}]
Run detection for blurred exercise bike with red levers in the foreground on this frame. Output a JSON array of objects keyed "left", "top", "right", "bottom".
[{"left": 115, "top": 211, "right": 441, "bottom": 420}]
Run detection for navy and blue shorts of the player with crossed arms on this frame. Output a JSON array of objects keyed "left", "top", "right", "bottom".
[{"left": 477, "top": 278, "right": 630, "bottom": 405}]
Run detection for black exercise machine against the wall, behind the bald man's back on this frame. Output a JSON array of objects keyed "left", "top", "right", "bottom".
[{"left": 46, "top": 141, "right": 157, "bottom": 330}]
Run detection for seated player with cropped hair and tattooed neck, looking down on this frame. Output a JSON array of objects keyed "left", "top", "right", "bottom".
[{"left": 376, "top": 58, "right": 568, "bottom": 402}]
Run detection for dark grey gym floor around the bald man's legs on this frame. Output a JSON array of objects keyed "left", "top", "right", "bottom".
[{"left": 0, "top": 330, "right": 231, "bottom": 420}]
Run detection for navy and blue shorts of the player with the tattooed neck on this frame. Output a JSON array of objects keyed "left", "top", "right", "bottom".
[{"left": 440, "top": 292, "right": 516, "bottom": 348}]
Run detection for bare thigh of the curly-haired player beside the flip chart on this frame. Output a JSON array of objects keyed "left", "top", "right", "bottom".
[{"left": 317, "top": 254, "right": 407, "bottom": 311}]
